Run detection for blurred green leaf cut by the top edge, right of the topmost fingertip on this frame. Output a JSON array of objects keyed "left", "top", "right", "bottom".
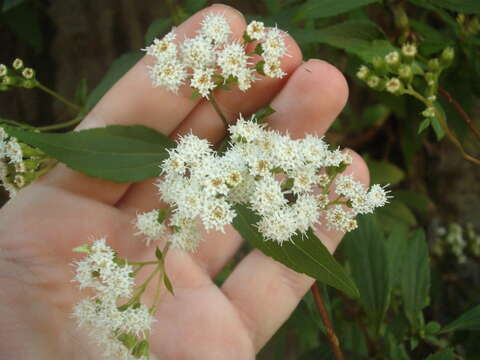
[{"left": 292, "top": 0, "right": 378, "bottom": 23}]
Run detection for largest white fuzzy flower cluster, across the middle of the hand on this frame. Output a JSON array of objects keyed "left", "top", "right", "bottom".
[{"left": 135, "top": 117, "right": 388, "bottom": 250}]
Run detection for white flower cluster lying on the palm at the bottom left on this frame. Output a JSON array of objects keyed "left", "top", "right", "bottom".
[{"left": 73, "top": 239, "right": 153, "bottom": 359}]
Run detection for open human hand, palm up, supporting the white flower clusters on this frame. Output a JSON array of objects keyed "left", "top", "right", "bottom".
[{"left": 0, "top": 5, "right": 368, "bottom": 360}]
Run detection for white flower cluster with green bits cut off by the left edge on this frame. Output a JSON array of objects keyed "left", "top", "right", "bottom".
[{"left": 0, "top": 127, "right": 47, "bottom": 198}]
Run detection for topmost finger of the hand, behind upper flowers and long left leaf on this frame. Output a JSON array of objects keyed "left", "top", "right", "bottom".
[{"left": 33, "top": 5, "right": 245, "bottom": 204}]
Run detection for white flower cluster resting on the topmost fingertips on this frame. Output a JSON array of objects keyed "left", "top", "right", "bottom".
[{"left": 145, "top": 13, "right": 287, "bottom": 98}]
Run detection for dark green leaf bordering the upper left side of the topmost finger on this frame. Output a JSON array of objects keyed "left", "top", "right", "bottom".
[{"left": 85, "top": 51, "right": 143, "bottom": 109}]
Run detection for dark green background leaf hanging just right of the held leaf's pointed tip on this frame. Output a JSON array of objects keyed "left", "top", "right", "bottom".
[{"left": 342, "top": 215, "right": 392, "bottom": 329}]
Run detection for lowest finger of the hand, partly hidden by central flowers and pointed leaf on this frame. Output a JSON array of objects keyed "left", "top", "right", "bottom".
[{"left": 222, "top": 153, "right": 369, "bottom": 351}]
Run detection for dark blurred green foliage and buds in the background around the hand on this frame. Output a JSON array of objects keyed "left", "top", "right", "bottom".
[{"left": 0, "top": 0, "right": 480, "bottom": 360}]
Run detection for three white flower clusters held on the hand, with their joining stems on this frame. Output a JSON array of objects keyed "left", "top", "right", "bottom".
[{"left": 67, "top": 13, "right": 389, "bottom": 359}]
